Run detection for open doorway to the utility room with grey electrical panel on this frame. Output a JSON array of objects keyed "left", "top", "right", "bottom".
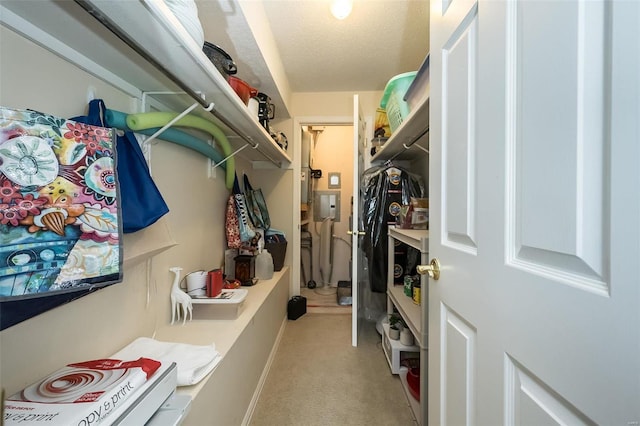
[{"left": 294, "top": 122, "right": 353, "bottom": 313}]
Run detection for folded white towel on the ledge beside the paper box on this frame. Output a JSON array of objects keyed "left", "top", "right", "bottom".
[{"left": 114, "top": 337, "right": 222, "bottom": 386}]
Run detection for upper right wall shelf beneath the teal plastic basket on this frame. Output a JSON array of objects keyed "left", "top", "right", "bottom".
[{"left": 371, "top": 96, "right": 429, "bottom": 163}]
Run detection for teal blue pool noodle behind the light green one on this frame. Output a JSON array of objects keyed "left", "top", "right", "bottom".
[{"left": 104, "top": 109, "right": 227, "bottom": 169}]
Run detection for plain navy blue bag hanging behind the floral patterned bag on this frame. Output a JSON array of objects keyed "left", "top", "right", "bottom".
[{"left": 72, "top": 99, "right": 169, "bottom": 233}]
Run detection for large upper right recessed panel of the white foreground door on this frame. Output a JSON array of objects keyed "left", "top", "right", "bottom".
[{"left": 506, "top": 2, "right": 611, "bottom": 295}]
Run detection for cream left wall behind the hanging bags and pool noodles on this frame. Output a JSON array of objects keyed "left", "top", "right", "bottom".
[{"left": 0, "top": 23, "right": 292, "bottom": 394}]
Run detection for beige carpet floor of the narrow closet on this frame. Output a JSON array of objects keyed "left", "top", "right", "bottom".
[{"left": 250, "top": 313, "right": 416, "bottom": 426}]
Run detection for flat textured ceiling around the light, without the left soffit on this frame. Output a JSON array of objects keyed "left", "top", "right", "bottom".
[{"left": 263, "top": 0, "right": 429, "bottom": 92}]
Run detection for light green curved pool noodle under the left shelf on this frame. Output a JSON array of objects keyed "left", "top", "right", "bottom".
[{"left": 127, "top": 112, "right": 236, "bottom": 190}]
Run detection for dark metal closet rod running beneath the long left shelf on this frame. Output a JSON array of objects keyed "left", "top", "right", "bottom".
[{"left": 75, "top": 0, "right": 281, "bottom": 167}]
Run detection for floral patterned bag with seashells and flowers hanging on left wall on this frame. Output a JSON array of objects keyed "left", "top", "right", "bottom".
[{"left": 0, "top": 107, "right": 122, "bottom": 329}]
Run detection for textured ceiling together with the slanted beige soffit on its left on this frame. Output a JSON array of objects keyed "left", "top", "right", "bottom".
[{"left": 199, "top": 0, "right": 429, "bottom": 118}]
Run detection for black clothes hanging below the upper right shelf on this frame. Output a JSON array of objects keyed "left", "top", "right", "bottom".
[{"left": 360, "top": 165, "right": 424, "bottom": 293}]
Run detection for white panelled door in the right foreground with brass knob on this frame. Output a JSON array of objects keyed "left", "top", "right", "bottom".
[{"left": 428, "top": 0, "right": 640, "bottom": 426}]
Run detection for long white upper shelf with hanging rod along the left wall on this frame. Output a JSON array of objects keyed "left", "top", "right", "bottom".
[{"left": 0, "top": 0, "right": 291, "bottom": 167}]
